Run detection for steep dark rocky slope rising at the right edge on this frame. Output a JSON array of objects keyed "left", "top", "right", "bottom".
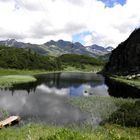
[{"left": 104, "top": 28, "right": 140, "bottom": 75}]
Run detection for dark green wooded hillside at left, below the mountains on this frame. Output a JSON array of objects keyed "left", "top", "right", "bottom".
[{"left": 0, "top": 46, "right": 61, "bottom": 70}]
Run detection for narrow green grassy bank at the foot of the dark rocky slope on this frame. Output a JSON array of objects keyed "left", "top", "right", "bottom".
[{"left": 110, "top": 76, "right": 140, "bottom": 89}]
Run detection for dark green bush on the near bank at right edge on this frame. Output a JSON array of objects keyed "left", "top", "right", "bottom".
[{"left": 107, "top": 100, "right": 140, "bottom": 127}]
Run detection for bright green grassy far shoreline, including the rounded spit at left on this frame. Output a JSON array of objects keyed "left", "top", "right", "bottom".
[{"left": 0, "top": 66, "right": 101, "bottom": 88}]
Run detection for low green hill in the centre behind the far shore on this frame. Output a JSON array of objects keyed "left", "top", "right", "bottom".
[{"left": 58, "top": 54, "right": 104, "bottom": 72}]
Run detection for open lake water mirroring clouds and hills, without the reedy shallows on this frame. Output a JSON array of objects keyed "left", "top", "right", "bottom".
[{"left": 0, "top": 72, "right": 140, "bottom": 124}]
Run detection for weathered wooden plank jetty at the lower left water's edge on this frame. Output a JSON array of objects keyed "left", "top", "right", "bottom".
[{"left": 0, "top": 116, "right": 20, "bottom": 128}]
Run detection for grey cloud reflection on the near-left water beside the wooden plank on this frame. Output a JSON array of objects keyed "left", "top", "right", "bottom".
[{"left": 0, "top": 90, "right": 86, "bottom": 124}]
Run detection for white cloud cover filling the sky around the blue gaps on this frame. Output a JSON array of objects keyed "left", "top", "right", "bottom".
[{"left": 0, "top": 0, "right": 140, "bottom": 47}]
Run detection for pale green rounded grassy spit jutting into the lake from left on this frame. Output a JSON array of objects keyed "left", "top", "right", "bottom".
[{"left": 0, "top": 75, "right": 36, "bottom": 88}]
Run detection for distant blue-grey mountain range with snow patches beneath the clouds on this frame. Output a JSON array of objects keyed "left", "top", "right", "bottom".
[{"left": 0, "top": 39, "right": 113, "bottom": 57}]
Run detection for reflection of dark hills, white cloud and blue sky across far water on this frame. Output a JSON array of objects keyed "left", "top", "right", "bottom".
[{"left": 1, "top": 73, "right": 108, "bottom": 96}]
